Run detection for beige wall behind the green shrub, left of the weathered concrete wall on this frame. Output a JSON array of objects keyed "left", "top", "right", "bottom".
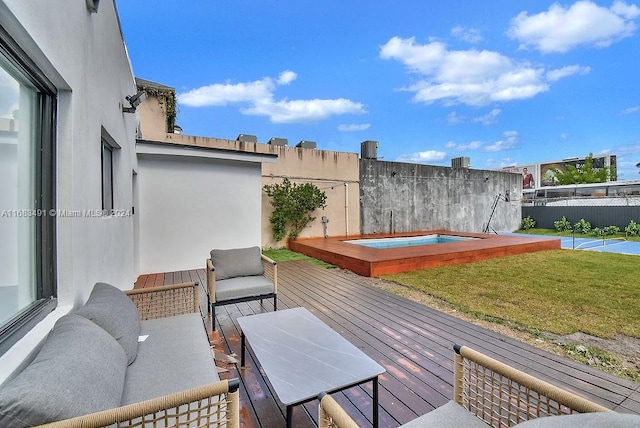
[{"left": 157, "top": 134, "right": 360, "bottom": 248}]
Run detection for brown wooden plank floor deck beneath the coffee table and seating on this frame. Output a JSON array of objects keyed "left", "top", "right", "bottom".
[{"left": 135, "top": 261, "right": 640, "bottom": 428}]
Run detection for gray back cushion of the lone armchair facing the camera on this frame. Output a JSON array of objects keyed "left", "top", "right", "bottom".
[{"left": 211, "top": 247, "right": 264, "bottom": 281}]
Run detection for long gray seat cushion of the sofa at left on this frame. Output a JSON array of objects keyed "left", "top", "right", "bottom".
[{"left": 122, "top": 313, "right": 220, "bottom": 405}]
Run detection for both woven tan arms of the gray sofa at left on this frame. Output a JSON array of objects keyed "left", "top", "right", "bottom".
[{"left": 27, "top": 282, "right": 240, "bottom": 428}]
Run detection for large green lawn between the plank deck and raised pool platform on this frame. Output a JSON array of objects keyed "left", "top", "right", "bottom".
[{"left": 383, "top": 250, "right": 640, "bottom": 338}]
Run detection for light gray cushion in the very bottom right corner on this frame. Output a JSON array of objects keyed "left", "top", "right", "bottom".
[{"left": 516, "top": 412, "right": 640, "bottom": 428}]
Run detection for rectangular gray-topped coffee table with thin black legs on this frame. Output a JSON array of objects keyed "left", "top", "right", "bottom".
[{"left": 238, "top": 308, "right": 385, "bottom": 427}]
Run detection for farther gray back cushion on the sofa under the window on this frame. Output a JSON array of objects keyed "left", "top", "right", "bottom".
[{"left": 75, "top": 282, "right": 140, "bottom": 364}]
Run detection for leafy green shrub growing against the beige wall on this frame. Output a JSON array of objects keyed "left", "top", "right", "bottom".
[{"left": 262, "top": 178, "right": 327, "bottom": 242}]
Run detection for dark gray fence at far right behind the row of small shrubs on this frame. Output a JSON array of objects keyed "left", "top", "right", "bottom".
[{"left": 522, "top": 206, "right": 640, "bottom": 230}]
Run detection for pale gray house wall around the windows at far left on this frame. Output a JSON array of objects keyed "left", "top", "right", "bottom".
[{"left": 0, "top": 0, "right": 137, "bottom": 382}]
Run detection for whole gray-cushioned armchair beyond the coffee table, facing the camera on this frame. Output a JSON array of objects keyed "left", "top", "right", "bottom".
[{"left": 206, "top": 247, "right": 278, "bottom": 330}]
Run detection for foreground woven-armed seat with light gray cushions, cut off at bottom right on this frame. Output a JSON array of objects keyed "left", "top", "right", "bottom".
[{"left": 318, "top": 345, "right": 640, "bottom": 428}]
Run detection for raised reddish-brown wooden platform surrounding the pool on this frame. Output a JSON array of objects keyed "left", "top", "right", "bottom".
[{"left": 288, "top": 230, "right": 561, "bottom": 277}]
